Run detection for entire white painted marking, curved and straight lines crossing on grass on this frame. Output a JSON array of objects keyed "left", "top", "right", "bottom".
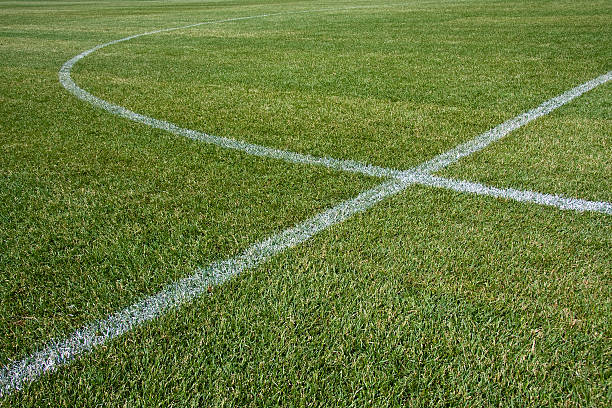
[{"left": 0, "top": 7, "right": 612, "bottom": 396}]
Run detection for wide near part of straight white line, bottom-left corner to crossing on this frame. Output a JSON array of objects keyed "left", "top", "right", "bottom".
[{"left": 0, "top": 179, "right": 411, "bottom": 396}]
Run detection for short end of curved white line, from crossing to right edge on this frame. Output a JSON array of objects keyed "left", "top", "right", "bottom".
[{"left": 408, "top": 174, "right": 612, "bottom": 215}]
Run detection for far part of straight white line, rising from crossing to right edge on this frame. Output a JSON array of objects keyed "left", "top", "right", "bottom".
[{"left": 413, "top": 71, "right": 612, "bottom": 173}]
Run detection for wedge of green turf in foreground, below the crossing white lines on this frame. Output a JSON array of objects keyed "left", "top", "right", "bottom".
[{"left": 5, "top": 187, "right": 611, "bottom": 406}]
